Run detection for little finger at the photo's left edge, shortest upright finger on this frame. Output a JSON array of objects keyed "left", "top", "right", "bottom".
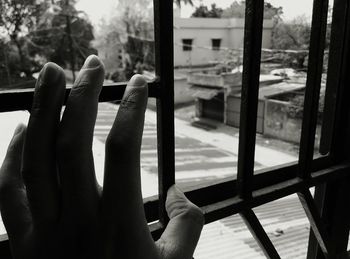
[{"left": 0, "top": 125, "right": 31, "bottom": 242}]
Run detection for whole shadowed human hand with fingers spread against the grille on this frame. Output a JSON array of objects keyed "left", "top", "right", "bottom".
[{"left": 0, "top": 56, "right": 203, "bottom": 259}]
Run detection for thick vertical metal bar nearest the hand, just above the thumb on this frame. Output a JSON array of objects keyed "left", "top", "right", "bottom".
[{"left": 153, "top": 0, "right": 175, "bottom": 224}]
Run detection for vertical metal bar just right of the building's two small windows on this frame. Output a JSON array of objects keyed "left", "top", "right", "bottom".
[{"left": 237, "top": 0, "right": 264, "bottom": 198}]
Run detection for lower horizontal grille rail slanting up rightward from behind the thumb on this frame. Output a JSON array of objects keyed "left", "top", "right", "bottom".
[{"left": 0, "top": 159, "right": 350, "bottom": 246}]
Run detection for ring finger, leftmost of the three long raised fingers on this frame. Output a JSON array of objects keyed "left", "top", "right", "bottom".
[{"left": 23, "top": 63, "right": 65, "bottom": 226}]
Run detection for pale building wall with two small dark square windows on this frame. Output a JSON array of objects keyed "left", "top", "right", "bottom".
[{"left": 174, "top": 18, "right": 272, "bottom": 66}]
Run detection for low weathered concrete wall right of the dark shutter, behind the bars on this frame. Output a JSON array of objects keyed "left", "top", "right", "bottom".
[{"left": 264, "top": 99, "right": 321, "bottom": 147}]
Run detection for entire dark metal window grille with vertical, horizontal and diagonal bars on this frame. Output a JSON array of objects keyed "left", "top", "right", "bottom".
[{"left": 0, "top": 0, "right": 350, "bottom": 258}]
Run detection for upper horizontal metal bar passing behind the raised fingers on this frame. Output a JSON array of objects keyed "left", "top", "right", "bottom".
[{"left": 0, "top": 81, "right": 159, "bottom": 112}]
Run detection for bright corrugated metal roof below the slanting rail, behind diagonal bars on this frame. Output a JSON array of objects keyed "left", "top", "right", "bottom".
[{"left": 194, "top": 195, "right": 310, "bottom": 259}]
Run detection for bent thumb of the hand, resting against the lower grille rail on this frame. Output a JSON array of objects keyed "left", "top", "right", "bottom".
[{"left": 157, "top": 185, "right": 204, "bottom": 259}]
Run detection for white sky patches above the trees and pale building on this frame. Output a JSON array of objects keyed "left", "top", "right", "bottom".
[{"left": 77, "top": 0, "right": 320, "bottom": 24}]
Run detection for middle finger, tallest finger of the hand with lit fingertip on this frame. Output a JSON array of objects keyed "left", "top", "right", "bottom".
[{"left": 57, "top": 55, "right": 104, "bottom": 223}]
